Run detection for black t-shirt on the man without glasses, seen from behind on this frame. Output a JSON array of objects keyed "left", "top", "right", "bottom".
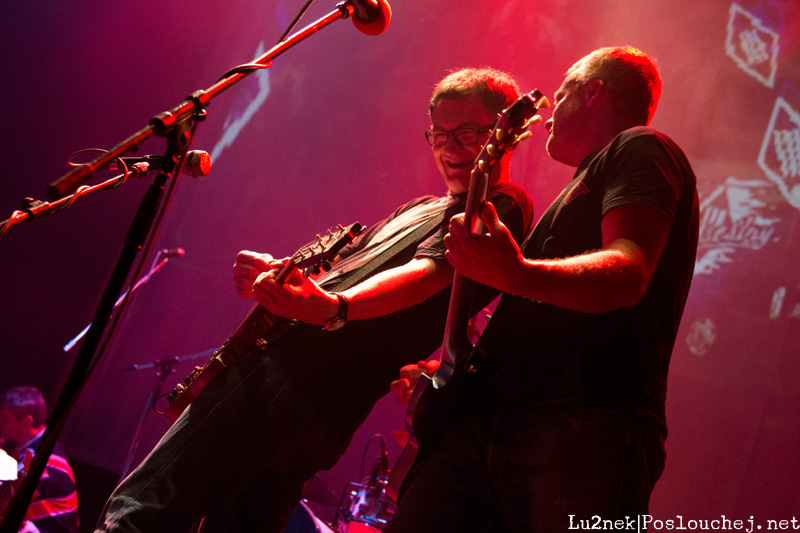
[{"left": 481, "top": 127, "right": 698, "bottom": 436}]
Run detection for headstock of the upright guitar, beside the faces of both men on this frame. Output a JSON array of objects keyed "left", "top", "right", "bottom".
[{"left": 474, "top": 90, "right": 550, "bottom": 174}]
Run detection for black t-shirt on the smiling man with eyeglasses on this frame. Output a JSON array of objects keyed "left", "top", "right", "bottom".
[{"left": 268, "top": 183, "right": 533, "bottom": 431}]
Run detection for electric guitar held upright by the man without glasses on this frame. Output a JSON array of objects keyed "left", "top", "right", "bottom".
[{"left": 386, "top": 90, "right": 550, "bottom": 502}]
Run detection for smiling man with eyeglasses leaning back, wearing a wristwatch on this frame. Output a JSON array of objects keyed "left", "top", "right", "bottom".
[{"left": 98, "top": 69, "right": 533, "bottom": 532}]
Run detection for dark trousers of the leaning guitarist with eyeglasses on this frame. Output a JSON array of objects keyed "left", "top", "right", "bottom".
[{"left": 97, "top": 354, "right": 347, "bottom": 533}]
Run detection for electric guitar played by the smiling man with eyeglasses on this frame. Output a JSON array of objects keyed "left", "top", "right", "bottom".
[{"left": 164, "top": 222, "right": 364, "bottom": 422}]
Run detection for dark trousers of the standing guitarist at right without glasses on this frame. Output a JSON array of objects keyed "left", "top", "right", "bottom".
[{"left": 384, "top": 407, "right": 665, "bottom": 533}]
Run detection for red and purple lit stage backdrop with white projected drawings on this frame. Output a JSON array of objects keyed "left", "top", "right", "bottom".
[{"left": 0, "top": 0, "right": 800, "bottom": 527}]
